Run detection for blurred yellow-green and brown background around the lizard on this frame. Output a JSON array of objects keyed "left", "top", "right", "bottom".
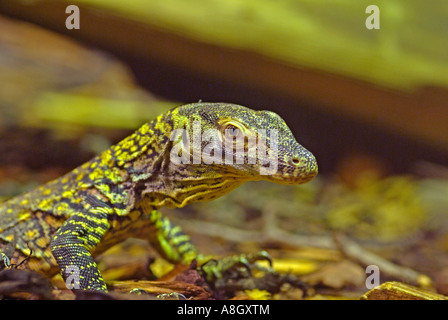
[{"left": 0, "top": 0, "right": 448, "bottom": 293}]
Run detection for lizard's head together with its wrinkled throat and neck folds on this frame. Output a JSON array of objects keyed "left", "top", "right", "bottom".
[{"left": 137, "top": 103, "right": 317, "bottom": 207}]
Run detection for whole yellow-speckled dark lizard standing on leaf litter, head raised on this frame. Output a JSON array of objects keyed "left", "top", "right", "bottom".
[{"left": 0, "top": 103, "right": 317, "bottom": 291}]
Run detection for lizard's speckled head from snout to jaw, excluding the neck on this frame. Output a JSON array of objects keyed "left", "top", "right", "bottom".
[{"left": 171, "top": 103, "right": 317, "bottom": 184}]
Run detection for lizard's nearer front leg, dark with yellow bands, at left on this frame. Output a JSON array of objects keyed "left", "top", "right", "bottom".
[{"left": 51, "top": 200, "right": 112, "bottom": 291}]
